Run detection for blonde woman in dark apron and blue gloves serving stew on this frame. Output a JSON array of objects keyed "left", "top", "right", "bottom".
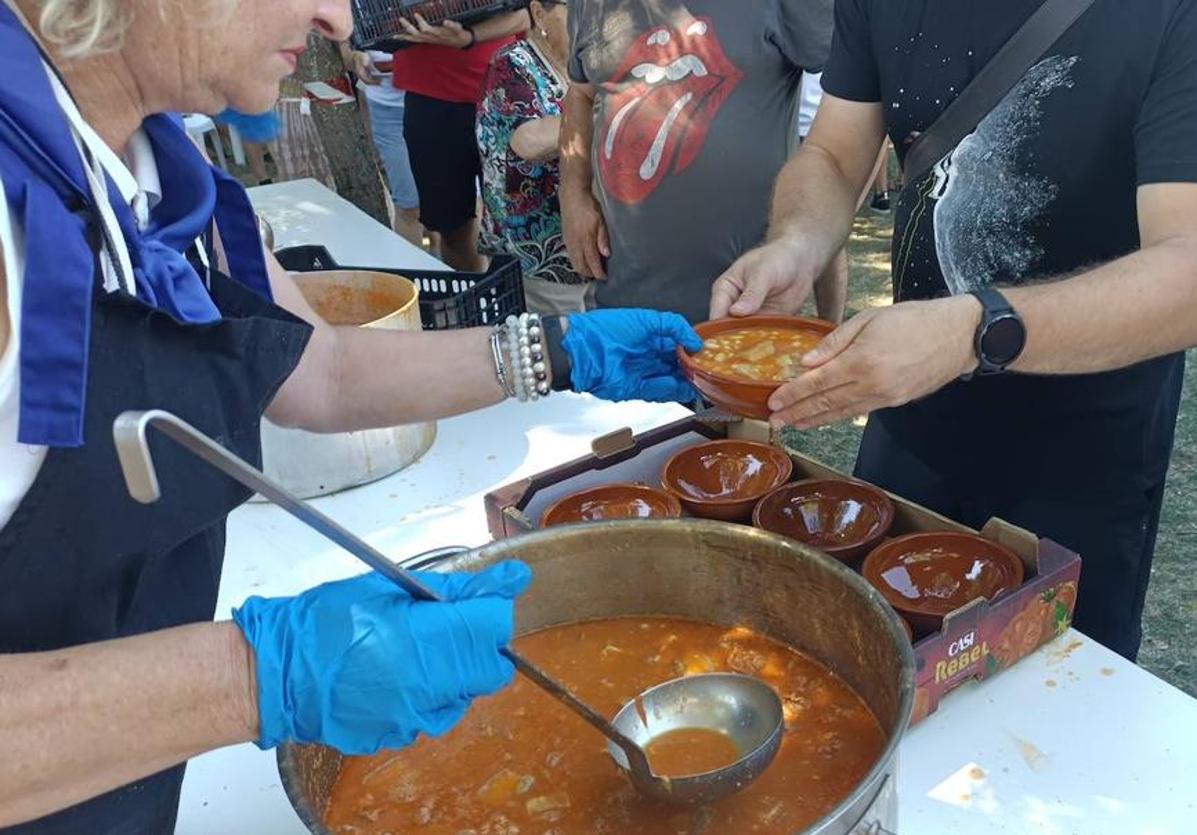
[{"left": 0, "top": 0, "right": 700, "bottom": 835}]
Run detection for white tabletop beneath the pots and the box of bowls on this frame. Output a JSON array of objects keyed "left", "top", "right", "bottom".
[{"left": 177, "top": 181, "right": 1197, "bottom": 835}]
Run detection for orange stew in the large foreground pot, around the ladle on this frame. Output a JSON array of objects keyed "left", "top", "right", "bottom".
[{"left": 324, "top": 617, "right": 885, "bottom": 835}]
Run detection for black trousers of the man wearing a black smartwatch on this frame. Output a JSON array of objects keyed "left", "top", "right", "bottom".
[{"left": 856, "top": 418, "right": 1163, "bottom": 662}]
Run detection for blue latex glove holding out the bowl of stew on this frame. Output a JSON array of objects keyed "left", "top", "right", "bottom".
[{"left": 561, "top": 309, "right": 703, "bottom": 403}]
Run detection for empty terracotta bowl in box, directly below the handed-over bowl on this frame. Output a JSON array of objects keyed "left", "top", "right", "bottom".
[{"left": 661, "top": 440, "right": 794, "bottom": 522}]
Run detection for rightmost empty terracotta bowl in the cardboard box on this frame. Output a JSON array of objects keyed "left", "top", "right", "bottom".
[{"left": 861, "top": 532, "right": 1022, "bottom": 635}]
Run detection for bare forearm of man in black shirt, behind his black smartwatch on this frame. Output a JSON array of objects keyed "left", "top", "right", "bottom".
[{"left": 1005, "top": 238, "right": 1197, "bottom": 374}]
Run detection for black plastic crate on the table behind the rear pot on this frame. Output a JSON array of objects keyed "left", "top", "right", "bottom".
[{"left": 274, "top": 245, "right": 525, "bottom": 330}]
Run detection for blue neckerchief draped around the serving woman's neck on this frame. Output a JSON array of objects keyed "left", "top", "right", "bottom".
[{"left": 0, "top": 4, "right": 271, "bottom": 446}]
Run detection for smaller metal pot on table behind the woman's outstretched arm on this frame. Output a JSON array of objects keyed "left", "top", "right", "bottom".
[{"left": 262, "top": 269, "right": 437, "bottom": 499}]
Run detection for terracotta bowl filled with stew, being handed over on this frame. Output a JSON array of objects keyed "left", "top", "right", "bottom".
[{"left": 678, "top": 316, "right": 836, "bottom": 420}]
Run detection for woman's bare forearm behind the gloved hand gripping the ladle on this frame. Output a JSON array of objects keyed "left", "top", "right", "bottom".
[{"left": 0, "top": 622, "right": 257, "bottom": 827}]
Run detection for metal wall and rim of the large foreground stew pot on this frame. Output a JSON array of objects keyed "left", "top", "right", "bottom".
[{"left": 278, "top": 519, "right": 915, "bottom": 835}]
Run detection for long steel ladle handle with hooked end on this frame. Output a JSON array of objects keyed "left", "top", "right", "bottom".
[{"left": 113, "top": 409, "right": 649, "bottom": 772}]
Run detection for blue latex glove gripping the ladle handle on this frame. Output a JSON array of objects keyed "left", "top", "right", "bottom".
[{"left": 232, "top": 561, "right": 531, "bottom": 754}]
